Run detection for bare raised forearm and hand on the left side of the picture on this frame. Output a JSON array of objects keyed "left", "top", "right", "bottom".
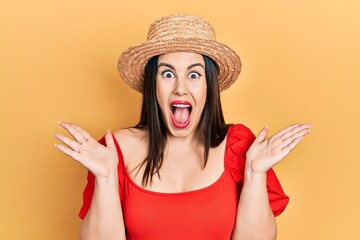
[{"left": 54, "top": 122, "right": 126, "bottom": 240}]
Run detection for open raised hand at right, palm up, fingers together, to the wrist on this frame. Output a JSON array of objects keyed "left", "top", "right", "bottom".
[{"left": 246, "top": 124, "right": 312, "bottom": 174}]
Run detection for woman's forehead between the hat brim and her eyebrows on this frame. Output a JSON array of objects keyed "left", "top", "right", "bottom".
[{"left": 158, "top": 52, "right": 205, "bottom": 66}]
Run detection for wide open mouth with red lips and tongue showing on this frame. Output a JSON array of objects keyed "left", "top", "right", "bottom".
[{"left": 170, "top": 101, "right": 192, "bottom": 128}]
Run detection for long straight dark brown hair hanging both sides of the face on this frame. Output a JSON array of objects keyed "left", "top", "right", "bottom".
[{"left": 135, "top": 55, "right": 229, "bottom": 186}]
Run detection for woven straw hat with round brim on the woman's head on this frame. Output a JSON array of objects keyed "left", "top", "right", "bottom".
[{"left": 118, "top": 14, "right": 241, "bottom": 93}]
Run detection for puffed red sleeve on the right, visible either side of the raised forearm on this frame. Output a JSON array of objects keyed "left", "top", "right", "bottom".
[{"left": 225, "top": 124, "right": 289, "bottom": 216}]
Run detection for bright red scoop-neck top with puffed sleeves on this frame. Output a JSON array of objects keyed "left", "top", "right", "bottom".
[{"left": 79, "top": 124, "right": 289, "bottom": 240}]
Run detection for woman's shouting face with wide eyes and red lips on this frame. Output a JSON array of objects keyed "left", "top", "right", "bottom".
[{"left": 156, "top": 52, "right": 207, "bottom": 137}]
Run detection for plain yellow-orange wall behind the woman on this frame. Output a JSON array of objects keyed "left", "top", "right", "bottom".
[{"left": 0, "top": 0, "right": 360, "bottom": 240}]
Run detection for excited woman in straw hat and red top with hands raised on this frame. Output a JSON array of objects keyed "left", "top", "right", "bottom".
[{"left": 55, "top": 15, "right": 311, "bottom": 240}]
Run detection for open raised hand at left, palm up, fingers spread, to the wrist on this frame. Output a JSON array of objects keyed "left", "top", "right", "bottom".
[{"left": 54, "top": 122, "right": 118, "bottom": 179}]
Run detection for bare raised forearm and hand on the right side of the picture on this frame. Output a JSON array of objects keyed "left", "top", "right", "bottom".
[{"left": 233, "top": 124, "right": 311, "bottom": 240}]
